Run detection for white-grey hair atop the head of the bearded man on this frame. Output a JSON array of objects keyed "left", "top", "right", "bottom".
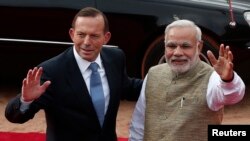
[{"left": 165, "top": 19, "right": 202, "bottom": 41}]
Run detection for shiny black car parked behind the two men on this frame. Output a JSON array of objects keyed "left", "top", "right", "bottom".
[{"left": 0, "top": 0, "right": 250, "bottom": 86}]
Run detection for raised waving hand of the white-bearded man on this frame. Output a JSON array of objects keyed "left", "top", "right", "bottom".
[{"left": 207, "top": 44, "right": 233, "bottom": 81}]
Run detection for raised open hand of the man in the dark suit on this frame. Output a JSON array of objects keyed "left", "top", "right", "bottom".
[{"left": 22, "top": 67, "right": 51, "bottom": 102}]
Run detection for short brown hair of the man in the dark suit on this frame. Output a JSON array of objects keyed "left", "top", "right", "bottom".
[{"left": 71, "top": 7, "right": 109, "bottom": 32}]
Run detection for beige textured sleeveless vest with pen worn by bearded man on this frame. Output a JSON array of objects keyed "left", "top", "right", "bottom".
[{"left": 144, "top": 61, "right": 223, "bottom": 141}]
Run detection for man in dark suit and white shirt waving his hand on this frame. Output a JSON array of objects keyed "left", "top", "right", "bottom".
[{"left": 5, "top": 7, "right": 142, "bottom": 141}]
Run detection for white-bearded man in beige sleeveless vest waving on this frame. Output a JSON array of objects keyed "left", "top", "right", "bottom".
[{"left": 129, "top": 20, "right": 245, "bottom": 141}]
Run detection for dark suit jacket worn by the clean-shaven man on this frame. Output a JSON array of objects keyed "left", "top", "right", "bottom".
[{"left": 5, "top": 47, "right": 142, "bottom": 141}]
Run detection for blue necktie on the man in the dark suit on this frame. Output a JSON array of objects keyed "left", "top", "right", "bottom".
[{"left": 89, "top": 62, "right": 105, "bottom": 126}]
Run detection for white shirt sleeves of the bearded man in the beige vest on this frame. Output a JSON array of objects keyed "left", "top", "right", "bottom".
[{"left": 129, "top": 71, "right": 245, "bottom": 141}]
